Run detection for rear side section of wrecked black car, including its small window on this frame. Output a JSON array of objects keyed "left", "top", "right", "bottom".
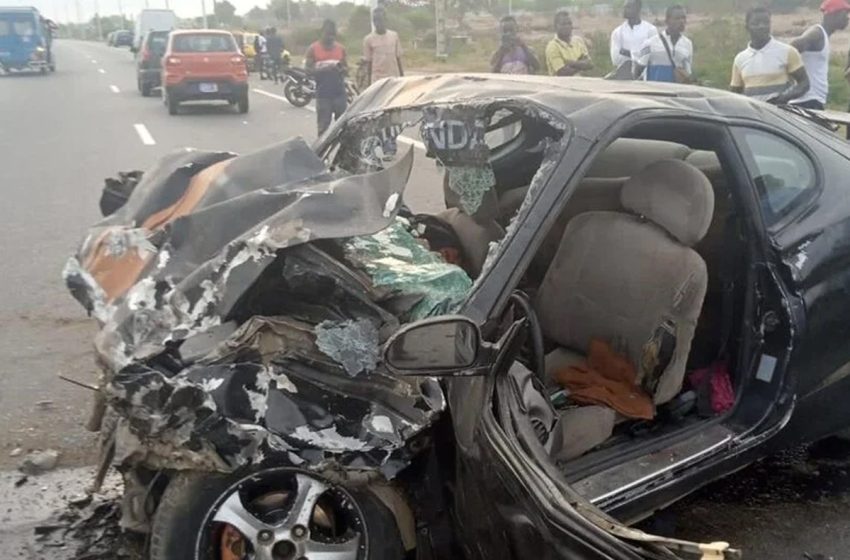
[{"left": 733, "top": 120, "right": 850, "bottom": 443}]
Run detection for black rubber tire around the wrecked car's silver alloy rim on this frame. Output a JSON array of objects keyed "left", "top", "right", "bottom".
[{"left": 150, "top": 472, "right": 405, "bottom": 560}]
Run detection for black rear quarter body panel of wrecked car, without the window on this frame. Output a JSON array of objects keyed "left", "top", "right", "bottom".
[{"left": 774, "top": 131, "right": 850, "bottom": 440}]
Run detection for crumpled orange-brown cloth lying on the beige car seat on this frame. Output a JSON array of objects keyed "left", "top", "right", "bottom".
[{"left": 552, "top": 339, "right": 655, "bottom": 420}]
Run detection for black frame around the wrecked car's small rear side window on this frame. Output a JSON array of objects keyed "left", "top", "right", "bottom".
[{"left": 729, "top": 121, "right": 824, "bottom": 233}]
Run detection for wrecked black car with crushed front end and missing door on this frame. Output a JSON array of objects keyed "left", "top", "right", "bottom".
[{"left": 65, "top": 75, "right": 850, "bottom": 560}]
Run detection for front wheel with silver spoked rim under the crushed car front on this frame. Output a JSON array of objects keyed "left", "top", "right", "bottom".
[{"left": 150, "top": 468, "right": 404, "bottom": 560}]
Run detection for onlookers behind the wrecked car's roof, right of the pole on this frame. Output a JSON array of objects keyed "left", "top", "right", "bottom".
[{"left": 491, "top": 0, "right": 850, "bottom": 109}]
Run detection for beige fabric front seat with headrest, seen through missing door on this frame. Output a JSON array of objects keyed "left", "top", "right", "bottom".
[{"left": 536, "top": 160, "right": 714, "bottom": 404}]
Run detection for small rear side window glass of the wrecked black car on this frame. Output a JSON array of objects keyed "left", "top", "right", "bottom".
[{"left": 740, "top": 129, "right": 817, "bottom": 219}]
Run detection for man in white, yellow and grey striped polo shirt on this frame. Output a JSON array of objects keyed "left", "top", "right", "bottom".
[{"left": 731, "top": 7, "right": 809, "bottom": 105}]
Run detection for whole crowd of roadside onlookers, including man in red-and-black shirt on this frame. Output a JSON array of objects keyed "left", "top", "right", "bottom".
[{"left": 274, "top": 0, "right": 850, "bottom": 134}]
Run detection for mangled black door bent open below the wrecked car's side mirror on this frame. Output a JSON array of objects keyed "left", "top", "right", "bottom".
[{"left": 438, "top": 295, "right": 738, "bottom": 560}]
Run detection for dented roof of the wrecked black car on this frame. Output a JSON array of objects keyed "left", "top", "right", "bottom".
[{"left": 350, "top": 74, "right": 775, "bottom": 130}]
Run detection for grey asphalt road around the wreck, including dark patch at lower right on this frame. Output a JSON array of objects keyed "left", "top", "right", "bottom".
[{"left": 0, "top": 41, "right": 850, "bottom": 560}]
